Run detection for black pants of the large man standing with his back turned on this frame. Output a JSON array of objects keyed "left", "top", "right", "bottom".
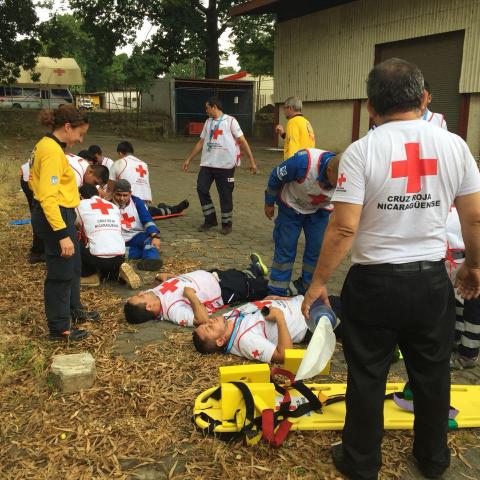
[{"left": 341, "top": 262, "right": 455, "bottom": 480}]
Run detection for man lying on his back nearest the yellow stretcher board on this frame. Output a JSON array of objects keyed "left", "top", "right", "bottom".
[{"left": 192, "top": 295, "right": 308, "bottom": 363}]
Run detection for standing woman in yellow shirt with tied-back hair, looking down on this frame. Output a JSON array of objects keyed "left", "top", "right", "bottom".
[{"left": 28, "top": 105, "right": 98, "bottom": 340}]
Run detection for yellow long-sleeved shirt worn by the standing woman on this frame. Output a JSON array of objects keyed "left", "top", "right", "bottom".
[{"left": 28, "top": 136, "right": 80, "bottom": 236}]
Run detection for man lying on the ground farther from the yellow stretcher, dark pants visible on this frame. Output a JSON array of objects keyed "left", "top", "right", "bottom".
[{"left": 124, "top": 253, "right": 268, "bottom": 327}]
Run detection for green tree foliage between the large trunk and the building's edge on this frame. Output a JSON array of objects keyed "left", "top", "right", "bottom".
[{"left": 231, "top": 15, "right": 275, "bottom": 76}]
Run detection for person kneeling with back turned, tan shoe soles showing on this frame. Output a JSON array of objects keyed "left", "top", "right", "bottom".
[{"left": 77, "top": 185, "right": 141, "bottom": 288}]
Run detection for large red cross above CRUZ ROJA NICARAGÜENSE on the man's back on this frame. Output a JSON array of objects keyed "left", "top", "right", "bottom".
[{"left": 392, "top": 143, "right": 438, "bottom": 193}]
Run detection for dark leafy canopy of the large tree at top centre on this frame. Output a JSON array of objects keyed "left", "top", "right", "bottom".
[{"left": 70, "top": 0, "right": 276, "bottom": 78}]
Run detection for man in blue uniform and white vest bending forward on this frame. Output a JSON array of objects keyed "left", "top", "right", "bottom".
[{"left": 265, "top": 148, "right": 339, "bottom": 296}]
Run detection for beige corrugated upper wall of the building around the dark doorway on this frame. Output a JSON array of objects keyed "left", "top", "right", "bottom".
[{"left": 275, "top": 0, "right": 480, "bottom": 103}]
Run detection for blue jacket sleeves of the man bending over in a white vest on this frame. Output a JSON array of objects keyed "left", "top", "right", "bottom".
[{"left": 265, "top": 150, "right": 335, "bottom": 206}]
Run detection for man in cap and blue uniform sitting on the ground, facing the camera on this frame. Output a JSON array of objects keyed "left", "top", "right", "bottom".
[{"left": 113, "top": 180, "right": 163, "bottom": 271}]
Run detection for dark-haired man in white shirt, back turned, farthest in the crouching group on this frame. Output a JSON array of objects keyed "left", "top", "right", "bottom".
[{"left": 108, "top": 142, "right": 152, "bottom": 204}]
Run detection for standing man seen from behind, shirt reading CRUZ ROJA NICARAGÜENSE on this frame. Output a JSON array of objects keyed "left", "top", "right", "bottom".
[{"left": 302, "top": 58, "right": 480, "bottom": 480}]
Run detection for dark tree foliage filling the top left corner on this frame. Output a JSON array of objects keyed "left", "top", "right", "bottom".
[{"left": 0, "top": 0, "right": 40, "bottom": 83}]
